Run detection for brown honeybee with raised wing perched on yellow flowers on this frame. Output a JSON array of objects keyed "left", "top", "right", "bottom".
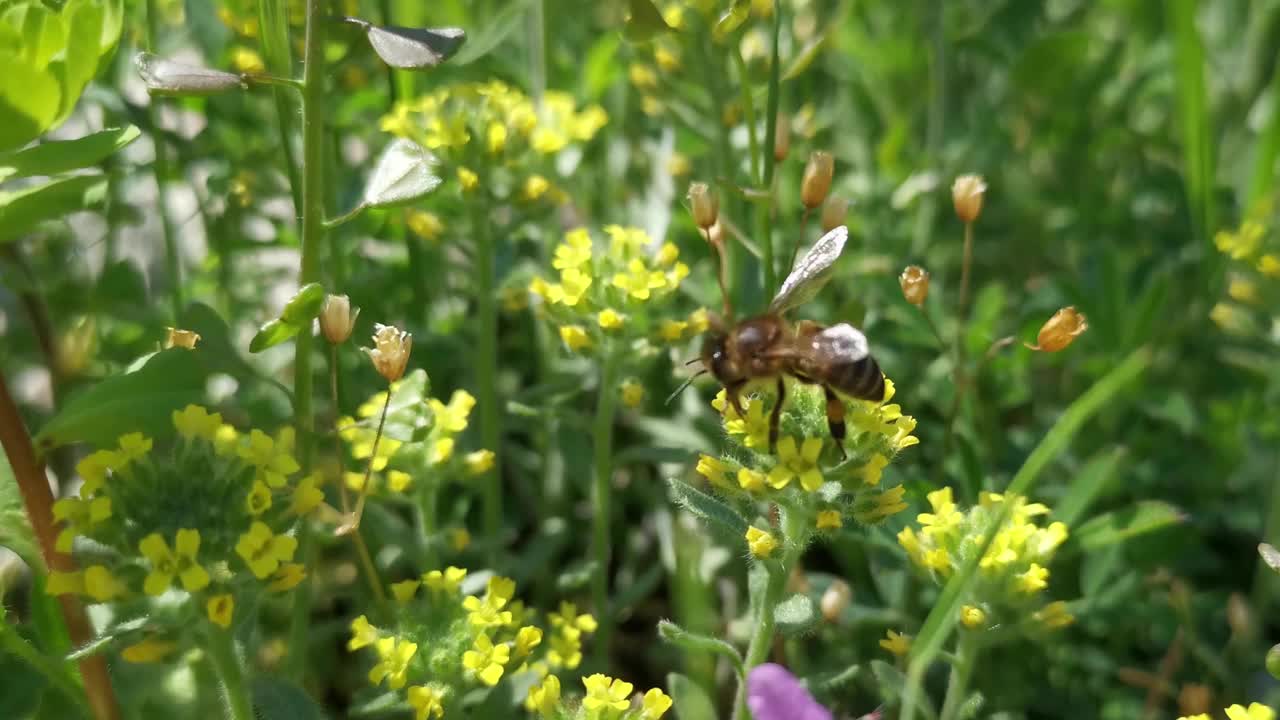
[{"left": 700, "top": 225, "right": 884, "bottom": 456}]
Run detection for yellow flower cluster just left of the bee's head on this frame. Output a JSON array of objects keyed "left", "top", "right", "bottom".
[{"left": 529, "top": 225, "right": 707, "bottom": 352}]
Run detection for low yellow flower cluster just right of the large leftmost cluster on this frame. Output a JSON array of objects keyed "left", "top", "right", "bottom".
[{"left": 347, "top": 568, "right": 595, "bottom": 720}]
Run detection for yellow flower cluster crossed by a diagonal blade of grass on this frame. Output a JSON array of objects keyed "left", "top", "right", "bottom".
[{"left": 897, "top": 487, "right": 1073, "bottom": 629}]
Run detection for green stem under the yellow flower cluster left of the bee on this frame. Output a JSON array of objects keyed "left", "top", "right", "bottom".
[{"left": 591, "top": 348, "right": 622, "bottom": 660}]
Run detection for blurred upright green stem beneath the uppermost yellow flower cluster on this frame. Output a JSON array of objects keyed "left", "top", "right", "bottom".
[{"left": 471, "top": 196, "right": 502, "bottom": 559}]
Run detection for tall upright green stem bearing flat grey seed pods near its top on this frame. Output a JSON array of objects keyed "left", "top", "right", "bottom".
[{"left": 288, "top": 0, "right": 329, "bottom": 679}]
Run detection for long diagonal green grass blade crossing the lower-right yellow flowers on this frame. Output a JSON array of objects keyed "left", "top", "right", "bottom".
[{"left": 901, "top": 347, "right": 1151, "bottom": 720}]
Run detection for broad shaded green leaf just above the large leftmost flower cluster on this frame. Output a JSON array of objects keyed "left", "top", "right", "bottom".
[{"left": 36, "top": 347, "right": 207, "bottom": 452}]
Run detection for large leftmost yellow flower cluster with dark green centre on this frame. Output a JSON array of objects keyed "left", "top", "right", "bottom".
[{"left": 49, "top": 405, "right": 313, "bottom": 657}]
